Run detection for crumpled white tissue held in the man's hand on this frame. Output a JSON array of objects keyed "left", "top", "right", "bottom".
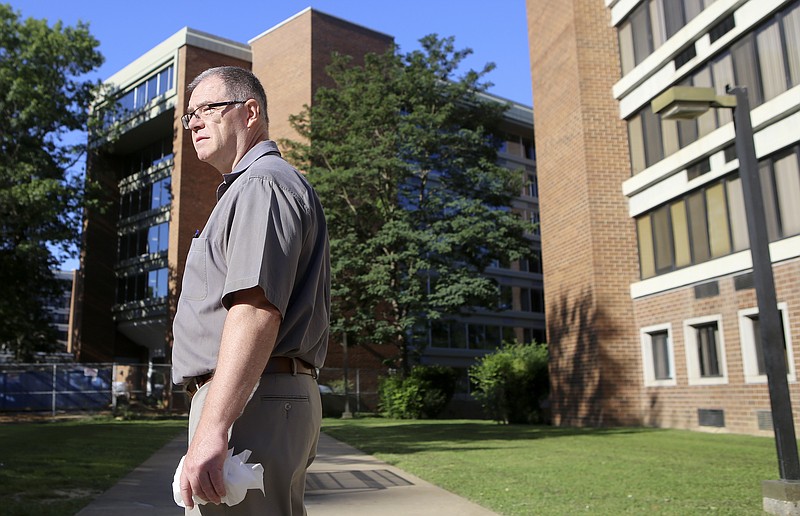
[{"left": 172, "top": 448, "right": 264, "bottom": 507}]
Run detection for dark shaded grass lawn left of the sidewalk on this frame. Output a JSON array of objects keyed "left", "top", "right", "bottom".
[{"left": 0, "top": 418, "right": 186, "bottom": 516}]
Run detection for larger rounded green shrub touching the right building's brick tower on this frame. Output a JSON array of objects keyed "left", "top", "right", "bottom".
[{"left": 470, "top": 343, "right": 550, "bottom": 423}]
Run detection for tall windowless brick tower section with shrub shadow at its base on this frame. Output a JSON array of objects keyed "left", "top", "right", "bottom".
[{"left": 527, "top": 0, "right": 642, "bottom": 425}]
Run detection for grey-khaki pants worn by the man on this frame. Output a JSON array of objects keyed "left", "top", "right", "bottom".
[{"left": 186, "top": 374, "right": 322, "bottom": 516}]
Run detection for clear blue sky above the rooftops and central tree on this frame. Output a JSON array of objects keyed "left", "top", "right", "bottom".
[{"left": 11, "top": 0, "right": 532, "bottom": 105}]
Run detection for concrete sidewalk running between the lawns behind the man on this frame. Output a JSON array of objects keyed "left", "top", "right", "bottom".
[{"left": 78, "top": 434, "right": 495, "bottom": 516}]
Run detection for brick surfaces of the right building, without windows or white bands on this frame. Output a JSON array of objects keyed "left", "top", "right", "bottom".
[{"left": 527, "top": 0, "right": 800, "bottom": 434}]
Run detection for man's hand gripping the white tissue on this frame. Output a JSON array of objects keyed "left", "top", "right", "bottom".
[{"left": 181, "top": 428, "right": 228, "bottom": 509}]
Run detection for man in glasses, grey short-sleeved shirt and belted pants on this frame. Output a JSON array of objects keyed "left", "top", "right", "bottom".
[{"left": 172, "top": 67, "right": 330, "bottom": 515}]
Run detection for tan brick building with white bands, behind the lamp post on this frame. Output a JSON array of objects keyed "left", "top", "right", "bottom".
[{"left": 527, "top": 0, "right": 800, "bottom": 434}]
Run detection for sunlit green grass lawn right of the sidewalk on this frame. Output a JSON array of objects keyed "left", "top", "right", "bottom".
[{"left": 323, "top": 418, "right": 779, "bottom": 515}]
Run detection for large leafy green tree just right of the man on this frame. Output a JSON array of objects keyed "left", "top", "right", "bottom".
[{"left": 282, "top": 35, "right": 532, "bottom": 372}]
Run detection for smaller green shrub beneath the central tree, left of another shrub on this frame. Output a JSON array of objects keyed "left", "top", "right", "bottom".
[{"left": 379, "top": 366, "right": 456, "bottom": 419}]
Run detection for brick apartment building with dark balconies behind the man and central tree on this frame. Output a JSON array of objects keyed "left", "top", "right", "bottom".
[{"left": 73, "top": 8, "right": 544, "bottom": 400}]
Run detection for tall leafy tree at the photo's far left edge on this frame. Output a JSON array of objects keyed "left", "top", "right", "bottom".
[{"left": 0, "top": 4, "right": 103, "bottom": 360}]
